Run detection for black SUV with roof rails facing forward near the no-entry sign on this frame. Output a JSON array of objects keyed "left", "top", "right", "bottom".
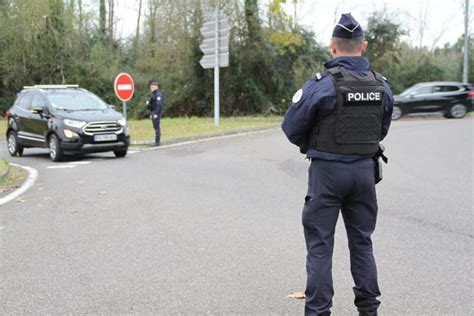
[{"left": 7, "top": 85, "right": 130, "bottom": 161}]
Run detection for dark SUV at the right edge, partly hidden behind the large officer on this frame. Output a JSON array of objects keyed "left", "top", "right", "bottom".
[{"left": 392, "top": 82, "right": 474, "bottom": 120}]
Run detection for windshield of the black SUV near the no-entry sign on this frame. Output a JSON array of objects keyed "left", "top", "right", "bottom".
[{"left": 46, "top": 90, "right": 107, "bottom": 111}]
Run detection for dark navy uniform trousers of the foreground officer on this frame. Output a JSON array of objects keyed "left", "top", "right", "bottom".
[{"left": 302, "top": 159, "right": 380, "bottom": 315}]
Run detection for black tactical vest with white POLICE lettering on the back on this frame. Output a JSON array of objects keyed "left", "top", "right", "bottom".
[{"left": 309, "top": 67, "right": 385, "bottom": 155}]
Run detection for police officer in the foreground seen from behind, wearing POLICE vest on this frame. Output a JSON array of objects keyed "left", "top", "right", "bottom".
[{"left": 282, "top": 13, "right": 393, "bottom": 316}]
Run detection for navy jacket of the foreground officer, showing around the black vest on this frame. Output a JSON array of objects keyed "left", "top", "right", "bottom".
[{"left": 282, "top": 57, "right": 393, "bottom": 162}]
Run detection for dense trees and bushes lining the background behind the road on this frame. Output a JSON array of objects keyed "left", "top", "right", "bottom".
[{"left": 0, "top": 0, "right": 474, "bottom": 118}]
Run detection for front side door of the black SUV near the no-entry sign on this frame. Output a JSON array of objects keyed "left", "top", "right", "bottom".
[{"left": 29, "top": 93, "right": 48, "bottom": 147}]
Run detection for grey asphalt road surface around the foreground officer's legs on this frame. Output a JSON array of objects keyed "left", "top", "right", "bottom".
[{"left": 0, "top": 119, "right": 474, "bottom": 315}]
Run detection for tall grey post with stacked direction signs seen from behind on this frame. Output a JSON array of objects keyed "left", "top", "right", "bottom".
[{"left": 199, "top": 7, "right": 229, "bottom": 126}]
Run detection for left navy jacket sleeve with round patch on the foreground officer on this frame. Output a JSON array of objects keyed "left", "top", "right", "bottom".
[{"left": 282, "top": 78, "right": 324, "bottom": 148}]
